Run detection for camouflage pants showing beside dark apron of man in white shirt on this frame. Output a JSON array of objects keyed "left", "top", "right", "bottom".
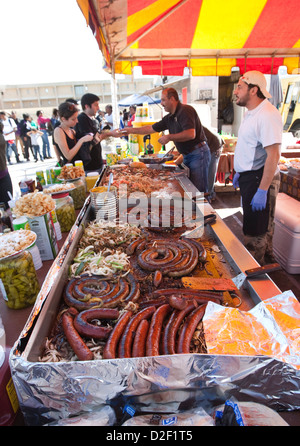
[{"left": 244, "top": 172, "right": 280, "bottom": 265}]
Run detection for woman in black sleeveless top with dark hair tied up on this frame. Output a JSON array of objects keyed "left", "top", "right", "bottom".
[{"left": 53, "top": 102, "right": 93, "bottom": 165}]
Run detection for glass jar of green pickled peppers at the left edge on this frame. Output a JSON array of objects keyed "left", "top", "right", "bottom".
[{"left": 0, "top": 251, "right": 40, "bottom": 310}]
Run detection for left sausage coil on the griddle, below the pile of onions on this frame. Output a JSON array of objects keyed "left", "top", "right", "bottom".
[{"left": 64, "top": 273, "right": 140, "bottom": 311}]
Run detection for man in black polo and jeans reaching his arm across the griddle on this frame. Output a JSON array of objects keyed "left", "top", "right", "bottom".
[{"left": 122, "top": 88, "right": 211, "bottom": 192}]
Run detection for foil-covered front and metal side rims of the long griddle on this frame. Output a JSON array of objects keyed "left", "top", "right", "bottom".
[{"left": 10, "top": 164, "right": 300, "bottom": 425}]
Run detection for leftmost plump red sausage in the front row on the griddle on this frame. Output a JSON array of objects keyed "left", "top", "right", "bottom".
[{"left": 62, "top": 311, "right": 94, "bottom": 361}]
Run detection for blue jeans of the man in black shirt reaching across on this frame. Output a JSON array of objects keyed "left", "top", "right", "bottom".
[{"left": 183, "top": 144, "right": 211, "bottom": 192}]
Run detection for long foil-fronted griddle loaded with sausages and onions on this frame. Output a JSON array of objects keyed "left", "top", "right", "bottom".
[{"left": 3, "top": 164, "right": 299, "bottom": 425}]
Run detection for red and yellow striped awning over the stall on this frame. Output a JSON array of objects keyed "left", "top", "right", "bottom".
[{"left": 77, "top": 0, "right": 300, "bottom": 76}]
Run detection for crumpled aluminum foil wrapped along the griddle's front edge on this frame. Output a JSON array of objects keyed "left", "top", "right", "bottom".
[{"left": 10, "top": 344, "right": 300, "bottom": 426}]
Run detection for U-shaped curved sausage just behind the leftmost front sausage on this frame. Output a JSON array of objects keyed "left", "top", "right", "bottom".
[{"left": 74, "top": 308, "right": 119, "bottom": 339}]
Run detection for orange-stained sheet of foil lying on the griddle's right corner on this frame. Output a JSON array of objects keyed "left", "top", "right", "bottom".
[{"left": 203, "top": 291, "right": 300, "bottom": 369}]
